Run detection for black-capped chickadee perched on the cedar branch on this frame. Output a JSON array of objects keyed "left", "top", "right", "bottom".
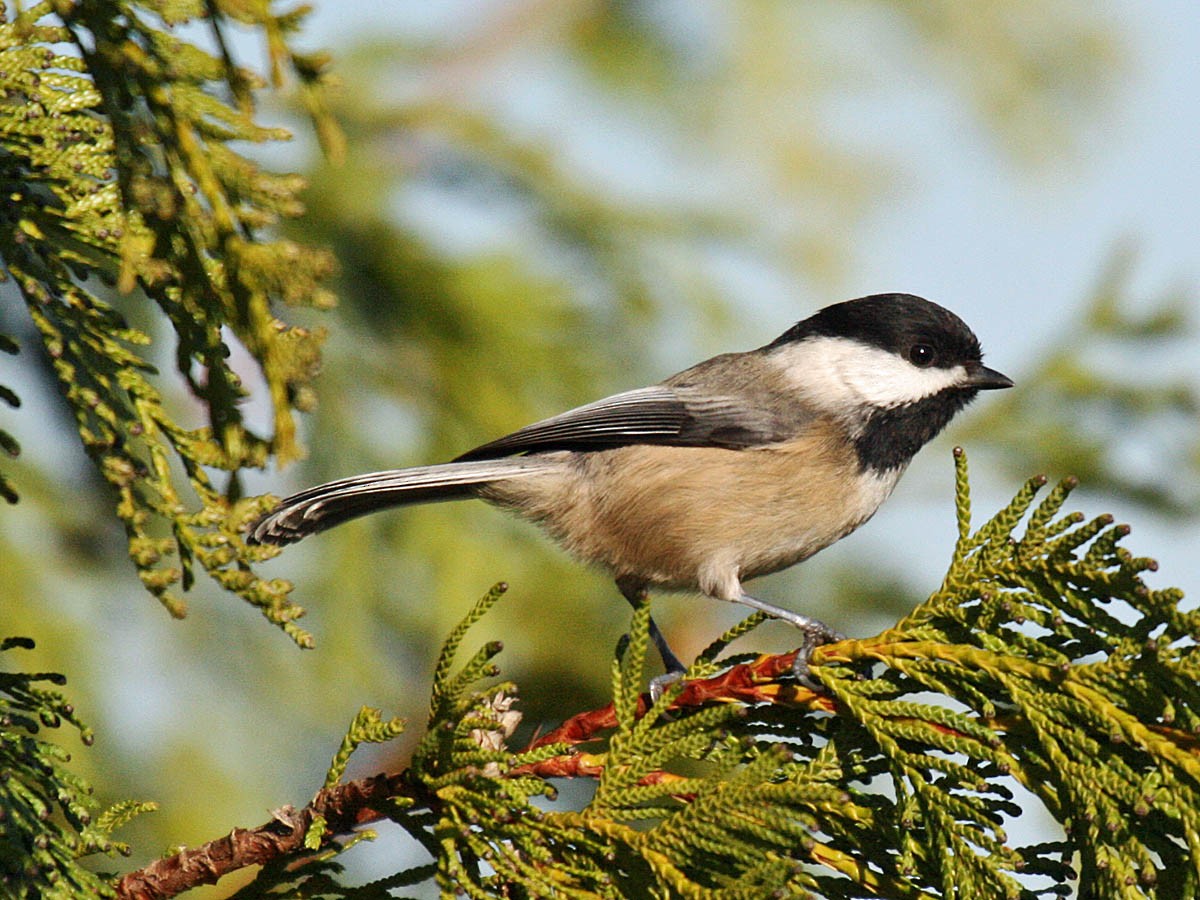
[{"left": 250, "top": 294, "right": 1013, "bottom": 673}]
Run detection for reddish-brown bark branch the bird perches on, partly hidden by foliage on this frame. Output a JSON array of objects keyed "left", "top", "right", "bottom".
[{"left": 116, "top": 653, "right": 835, "bottom": 900}]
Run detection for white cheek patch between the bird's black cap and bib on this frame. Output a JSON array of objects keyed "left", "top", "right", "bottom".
[{"left": 770, "top": 336, "right": 967, "bottom": 412}]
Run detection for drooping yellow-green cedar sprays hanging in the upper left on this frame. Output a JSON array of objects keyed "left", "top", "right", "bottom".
[{"left": 0, "top": 0, "right": 334, "bottom": 643}]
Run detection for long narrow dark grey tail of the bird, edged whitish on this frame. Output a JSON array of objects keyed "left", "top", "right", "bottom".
[{"left": 247, "top": 457, "right": 552, "bottom": 545}]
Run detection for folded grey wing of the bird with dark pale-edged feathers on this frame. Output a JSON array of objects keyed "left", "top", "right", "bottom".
[{"left": 457, "top": 354, "right": 812, "bottom": 461}]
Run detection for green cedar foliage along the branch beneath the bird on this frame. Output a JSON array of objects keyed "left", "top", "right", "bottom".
[{"left": 223, "top": 451, "right": 1200, "bottom": 900}]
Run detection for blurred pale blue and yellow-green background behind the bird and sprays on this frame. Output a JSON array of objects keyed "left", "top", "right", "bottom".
[{"left": 0, "top": 0, "right": 1200, "bottom": 895}]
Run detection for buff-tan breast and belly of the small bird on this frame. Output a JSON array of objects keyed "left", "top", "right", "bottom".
[{"left": 491, "top": 431, "right": 900, "bottom": 599}]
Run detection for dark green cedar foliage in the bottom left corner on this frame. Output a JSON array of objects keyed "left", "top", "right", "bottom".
[{"left": 0, "top": 637, "right": 154, "bottom": 900}]
